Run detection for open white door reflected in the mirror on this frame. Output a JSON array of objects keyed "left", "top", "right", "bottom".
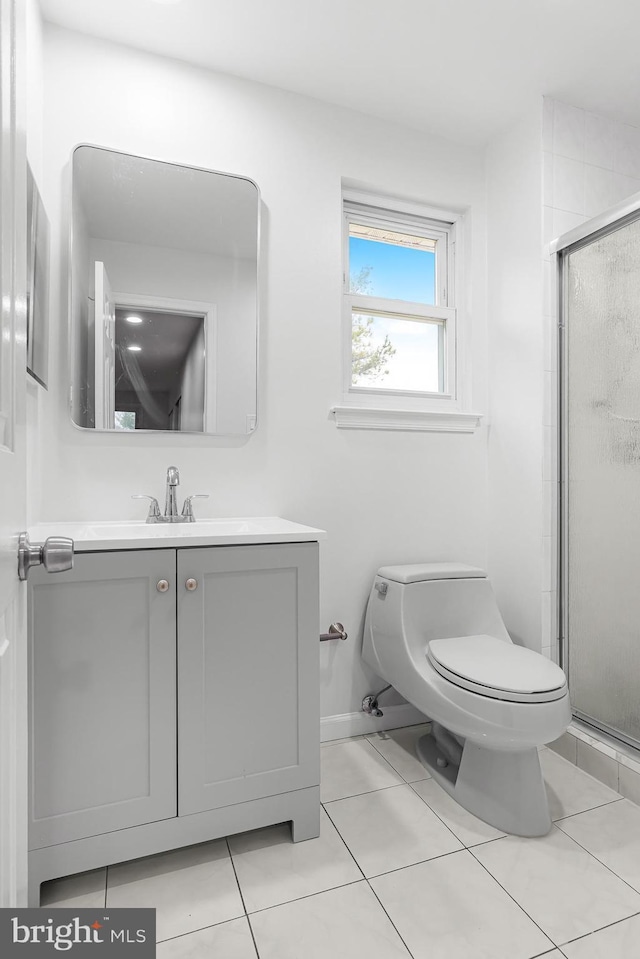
[{"left": 94, "top": 260, "right": 116, "bottom": 430}]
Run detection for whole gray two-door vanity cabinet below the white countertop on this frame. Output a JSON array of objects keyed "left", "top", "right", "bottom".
[{"left": 28, "top": 542, "right": 320, "bottom": 904}]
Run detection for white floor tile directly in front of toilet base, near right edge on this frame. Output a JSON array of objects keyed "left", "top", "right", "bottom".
[{"left": 473, "top": 826, "right": 640, "bottom": 945}]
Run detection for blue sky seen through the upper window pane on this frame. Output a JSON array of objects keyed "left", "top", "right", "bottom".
[{"left": 349, "top": 236, "right": 436, "bottom": 304}]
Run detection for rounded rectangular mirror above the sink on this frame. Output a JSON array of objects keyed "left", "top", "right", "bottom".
[{"left": 71, "top": 146, "right": 259, "bottom": 435}]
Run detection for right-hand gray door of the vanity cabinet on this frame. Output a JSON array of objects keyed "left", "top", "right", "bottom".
[{"left": 178, "top": 543, "right": 320, "bottom": 816}]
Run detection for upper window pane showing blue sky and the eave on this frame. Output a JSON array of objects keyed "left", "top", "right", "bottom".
[{"left": 349, "top": 223, "right": 436, "bottom": 304}]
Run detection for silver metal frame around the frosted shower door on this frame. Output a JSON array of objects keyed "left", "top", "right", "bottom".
[{"left": 549, "top": 193, "right": 640, "bottom": 752}]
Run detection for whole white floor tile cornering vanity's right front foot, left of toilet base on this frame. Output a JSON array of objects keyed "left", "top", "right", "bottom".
[{"left": 327, "top": 786, "right": 462, "bottom": 877}]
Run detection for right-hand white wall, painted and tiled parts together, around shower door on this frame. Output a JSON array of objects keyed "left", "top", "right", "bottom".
[{"left": 487, "top": 98, "right": 640, "bottom": 661}]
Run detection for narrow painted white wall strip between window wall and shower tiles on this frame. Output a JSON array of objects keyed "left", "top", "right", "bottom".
[{"left": 486, "top": 110, "right": 544, "bottom": 650}]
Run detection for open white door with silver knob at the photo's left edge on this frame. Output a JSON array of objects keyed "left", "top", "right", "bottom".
[{"left": 0, "top": 0, "right": 27, "bottom": 907}]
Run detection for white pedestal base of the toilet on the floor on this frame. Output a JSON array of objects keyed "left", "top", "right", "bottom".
[{"left": 416, "top": 734, "right": 551, "bottom": 836}]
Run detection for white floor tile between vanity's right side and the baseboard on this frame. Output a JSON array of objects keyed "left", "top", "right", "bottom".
[{"left": 320, "top": 739, "right": 404, "bottom": 802}]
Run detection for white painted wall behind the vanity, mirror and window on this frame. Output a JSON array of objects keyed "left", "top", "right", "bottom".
[{"left": 32, "top": 27, "right": 487, "bottom": 716}]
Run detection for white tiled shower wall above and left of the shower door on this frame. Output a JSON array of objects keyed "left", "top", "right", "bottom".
[{"left": 541, "top": 97, "right": 640, "bottom": 662}]
